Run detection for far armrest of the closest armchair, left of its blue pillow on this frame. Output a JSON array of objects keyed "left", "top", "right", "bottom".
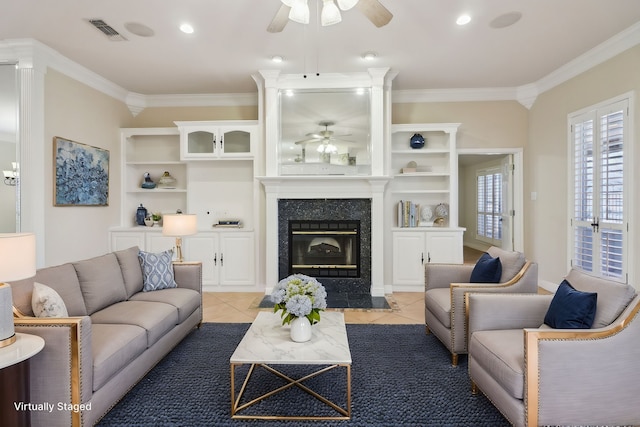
[{"left": 467, "top": 293, "right": 553, "bottom": 336}]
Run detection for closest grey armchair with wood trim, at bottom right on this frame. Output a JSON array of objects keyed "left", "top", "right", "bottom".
[{"left": 468, "top": 270, "right": 640, "bottom": 427}]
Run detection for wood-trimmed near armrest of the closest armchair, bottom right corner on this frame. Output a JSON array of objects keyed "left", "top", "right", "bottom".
[{"left": 524, "top": 295, "right": 640, "bottom": 425}]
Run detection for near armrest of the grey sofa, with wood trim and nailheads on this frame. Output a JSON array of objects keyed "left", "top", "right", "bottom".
[{"left": 14, "top": 316, "right": 93, "bottom": 426}]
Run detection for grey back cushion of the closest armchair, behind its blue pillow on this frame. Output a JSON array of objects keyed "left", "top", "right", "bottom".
[{"left": 566, "top": 269, "right": 636, "bottom": 328}]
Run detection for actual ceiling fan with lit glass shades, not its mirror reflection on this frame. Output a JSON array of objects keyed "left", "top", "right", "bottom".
[{"left": 267, "top": 0, "right": 393, "bottom": 33}]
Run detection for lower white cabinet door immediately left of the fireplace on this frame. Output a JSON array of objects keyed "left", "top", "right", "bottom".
[{"left": 219, "top": 233, "right": 255, "bottom": 286}]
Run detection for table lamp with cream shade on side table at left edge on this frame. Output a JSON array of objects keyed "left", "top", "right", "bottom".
[{"left": 0, "top": 233, "right": 36, "bottom": 347}]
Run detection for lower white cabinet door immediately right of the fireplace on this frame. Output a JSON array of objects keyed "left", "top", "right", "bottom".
[{"left": 393, "top": 232, "right": 426, "bottom": 285}]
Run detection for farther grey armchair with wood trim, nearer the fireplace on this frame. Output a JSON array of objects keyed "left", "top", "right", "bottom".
[{"left": 424, "top": 246, "right": 538, "bottom": 366}]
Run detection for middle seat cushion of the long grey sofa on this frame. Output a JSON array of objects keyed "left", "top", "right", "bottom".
[{"left": 91, "top": 301, "right": 178, "bottom": 347}]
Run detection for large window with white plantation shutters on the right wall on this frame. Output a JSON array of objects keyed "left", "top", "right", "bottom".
[{"left": 570, "top": 99, "right": 630, "bottom": 282}]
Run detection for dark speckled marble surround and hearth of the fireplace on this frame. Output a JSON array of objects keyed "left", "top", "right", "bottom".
[{"left": 278, "top": 199, "right": 390, "bottom": 309}]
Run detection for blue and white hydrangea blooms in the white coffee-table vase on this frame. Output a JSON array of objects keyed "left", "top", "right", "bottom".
[{"left": 271, "top": 274, "right": 327, "bottom": 325}]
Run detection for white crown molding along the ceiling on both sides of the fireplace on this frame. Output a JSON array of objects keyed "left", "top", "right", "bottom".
[{"left": 0, "top": 23, "right": 640, "bottom": 112}]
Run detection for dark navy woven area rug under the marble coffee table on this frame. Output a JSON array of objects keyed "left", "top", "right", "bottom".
[{"left": 98, "top": 323, "right": 509, "bottom": 427}]
